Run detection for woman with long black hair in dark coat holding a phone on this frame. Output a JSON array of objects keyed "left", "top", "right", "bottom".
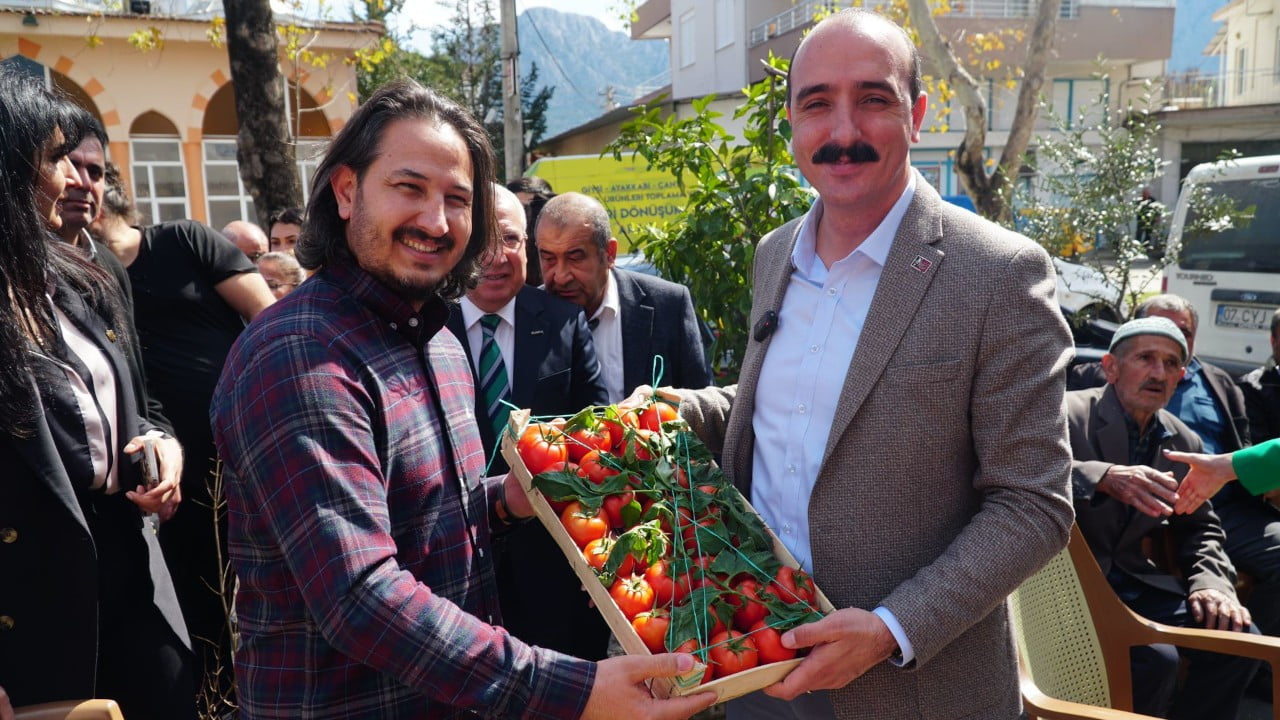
[{"left": 0, "top": 69, "right": 195, "bottom": 720}]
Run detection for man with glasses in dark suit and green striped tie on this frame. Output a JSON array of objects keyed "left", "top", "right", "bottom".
[{"left": 448, "top": 184, "right": 608, "bottom": 660}]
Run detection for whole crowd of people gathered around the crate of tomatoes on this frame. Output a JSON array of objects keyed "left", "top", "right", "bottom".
[{"left": 0, "top": 5, "right": 1280, "bottom": 720}]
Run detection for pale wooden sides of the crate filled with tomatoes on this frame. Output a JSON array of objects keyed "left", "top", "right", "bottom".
[{"left": 502, "top": 410, "right": 835, "bottom": 703}]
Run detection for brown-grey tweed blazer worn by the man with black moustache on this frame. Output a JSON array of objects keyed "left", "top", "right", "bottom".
[{"left": 681, "top": 176, "right": 1073, "bottom": 720}]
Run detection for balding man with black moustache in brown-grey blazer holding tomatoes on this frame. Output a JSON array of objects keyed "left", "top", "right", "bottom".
[{"left": 681, "top": 10, "right": 1073, "bottom": 720}]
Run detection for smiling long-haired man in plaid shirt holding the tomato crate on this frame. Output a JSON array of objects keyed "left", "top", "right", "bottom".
[{"left": 211, "top": 81, "right": 712, "bottom": 719}]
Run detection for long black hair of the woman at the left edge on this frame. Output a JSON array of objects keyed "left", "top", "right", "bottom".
[{"left": 0, "top": 67, "right": 123, "bottom": 436}]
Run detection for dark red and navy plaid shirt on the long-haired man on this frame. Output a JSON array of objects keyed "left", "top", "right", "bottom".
[{"left": 210, "top": 258, "right": 595, "bottom": 720}]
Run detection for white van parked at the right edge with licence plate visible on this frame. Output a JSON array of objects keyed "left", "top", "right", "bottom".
[{"left": 1165, "top": 155, "right": 1280, "bottom": 374}]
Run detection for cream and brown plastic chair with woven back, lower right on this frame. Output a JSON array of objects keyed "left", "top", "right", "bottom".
[{"left": 1010, "top": 525, "right": 1280, "bottom": 720}]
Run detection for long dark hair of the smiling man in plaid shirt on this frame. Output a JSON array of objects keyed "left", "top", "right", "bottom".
[{"left": 293, "top": 79, "right": 498, "bottom": 300}]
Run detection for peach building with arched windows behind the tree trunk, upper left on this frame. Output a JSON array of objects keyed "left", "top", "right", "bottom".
[{"left": 0, "top": 0, "right": 381, "bottom": 228}]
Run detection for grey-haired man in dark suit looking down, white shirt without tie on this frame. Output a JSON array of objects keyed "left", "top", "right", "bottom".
[{"left": 536, "top": 192, "right": 712, "bottom": 402}]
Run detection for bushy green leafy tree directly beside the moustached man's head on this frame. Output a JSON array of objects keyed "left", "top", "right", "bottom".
[{"left": 604, "top": 55, "right": 813, "bottom": 382}]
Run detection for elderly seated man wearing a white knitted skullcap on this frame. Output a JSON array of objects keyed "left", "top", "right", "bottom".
[{"left": 1066, "top": 316, "right": 1257, "bottom": 720}]
